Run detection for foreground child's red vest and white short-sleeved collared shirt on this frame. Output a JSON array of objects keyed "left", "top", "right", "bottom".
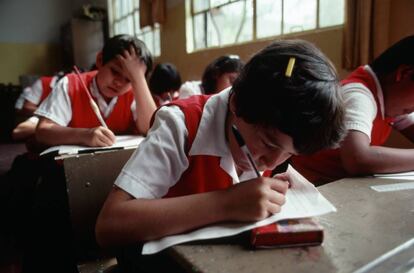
[{"left": 115, "top": 88, "right": 256, "bottom": 199}]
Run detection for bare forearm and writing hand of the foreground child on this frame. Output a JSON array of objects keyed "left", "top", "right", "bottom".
[{"left": 95, "top": 177, "right": 288, "bottom": 246}]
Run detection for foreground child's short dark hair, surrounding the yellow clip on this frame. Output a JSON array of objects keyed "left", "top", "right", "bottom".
[{"left": 232, "top": 40, "right": 345, "bottom": 154}]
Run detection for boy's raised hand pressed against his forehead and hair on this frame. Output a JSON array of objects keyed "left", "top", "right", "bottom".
[{"left": 117, "top": 45, "right": 147, "bottom": 82}]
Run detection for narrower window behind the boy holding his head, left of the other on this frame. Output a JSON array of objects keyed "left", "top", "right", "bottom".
[{"left": 108, "top": 0, "right": 161, "bottom": 57}]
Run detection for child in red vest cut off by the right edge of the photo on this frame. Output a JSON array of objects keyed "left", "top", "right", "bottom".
[{"left": 292, "top": 33, "right": 414, "bottom": 184}]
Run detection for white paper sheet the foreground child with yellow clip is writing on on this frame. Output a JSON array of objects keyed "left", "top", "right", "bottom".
[{"left": 142, "top": 166, "right": 336, "bottom": 254}]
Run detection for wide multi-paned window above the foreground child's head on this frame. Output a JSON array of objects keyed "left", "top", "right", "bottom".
[{"left": 186, "top": 0, "right": 345, "bottom": 52}]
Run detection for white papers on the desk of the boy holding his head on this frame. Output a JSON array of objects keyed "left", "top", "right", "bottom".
[{"left": 40, "top": 135, "right": 144, "bottom": 156}]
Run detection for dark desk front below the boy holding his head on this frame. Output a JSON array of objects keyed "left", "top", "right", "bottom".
[{"left": 62, "top": 149, "right": 135, "bottom": 250}]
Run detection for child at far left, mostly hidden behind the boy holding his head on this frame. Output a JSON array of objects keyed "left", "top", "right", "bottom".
[{"left": 12, "top": 72, "right": 64, "bottom": 140}]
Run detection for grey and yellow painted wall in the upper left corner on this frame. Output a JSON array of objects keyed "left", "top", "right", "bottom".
[{"left": 0, "top": 0, "right": 71, "bottom": 84}]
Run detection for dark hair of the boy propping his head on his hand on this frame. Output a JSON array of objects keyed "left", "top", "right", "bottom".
[{"left": 102, "top": 34, "right": 152, "bottom": 76}]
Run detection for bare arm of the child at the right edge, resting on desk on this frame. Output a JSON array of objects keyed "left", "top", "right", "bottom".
[{"left": 341, "top": 130, "right": 414, "bottom": 175}]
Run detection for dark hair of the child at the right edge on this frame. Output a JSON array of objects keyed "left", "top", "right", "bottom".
[{"left": 370, "top": 35, "right": 414, "bottom": 76}]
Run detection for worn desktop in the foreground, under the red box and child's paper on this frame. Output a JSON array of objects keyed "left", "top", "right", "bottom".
[{"left": 168, "top": 178, "right": 414, "bottom": 273}]
